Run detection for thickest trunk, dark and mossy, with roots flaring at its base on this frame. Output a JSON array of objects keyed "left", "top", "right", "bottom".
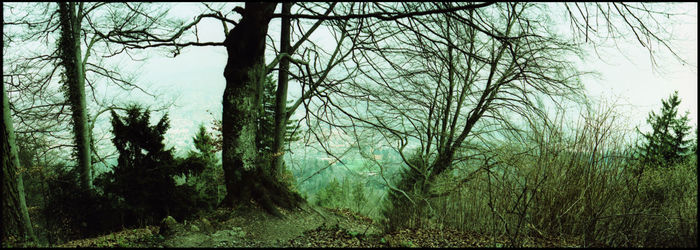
[{"left": 221, "top": 3, "right": 303, "bottom": 216}]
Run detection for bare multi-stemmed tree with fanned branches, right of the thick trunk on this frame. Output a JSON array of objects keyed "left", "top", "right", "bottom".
[{"left": 298, "top": 3, "right": 682, "bottom": 230}]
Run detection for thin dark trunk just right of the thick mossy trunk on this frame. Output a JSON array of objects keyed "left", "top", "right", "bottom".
[{"left": 272, "top": 2, "right": 292, "bottom": 176}]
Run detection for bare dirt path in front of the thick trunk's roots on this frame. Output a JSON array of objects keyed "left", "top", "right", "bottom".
[{"left": 158, "top": 206, "right": 379, "bottom": 247}]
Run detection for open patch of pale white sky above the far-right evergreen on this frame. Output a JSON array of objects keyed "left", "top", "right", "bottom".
[{"left": 581, "top": 3, "right": 698, "bottom": 131}]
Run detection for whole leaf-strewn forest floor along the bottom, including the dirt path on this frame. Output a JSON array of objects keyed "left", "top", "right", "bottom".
[{"left": 57, "top": 205, "right": 580, "bottom": 247}]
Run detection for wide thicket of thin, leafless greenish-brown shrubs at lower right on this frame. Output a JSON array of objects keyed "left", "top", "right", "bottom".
[{"left": 432, "top": 104, "right": 697, "bottom": 247}]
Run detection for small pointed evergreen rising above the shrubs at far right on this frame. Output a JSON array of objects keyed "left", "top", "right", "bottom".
[{"left": 639, "top": 91, "right": 691, "bottom": 167}]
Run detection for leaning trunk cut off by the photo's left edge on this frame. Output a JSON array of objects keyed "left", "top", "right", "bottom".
[{"left": 0, "top": 83, "right": 36, "bottom": 242}]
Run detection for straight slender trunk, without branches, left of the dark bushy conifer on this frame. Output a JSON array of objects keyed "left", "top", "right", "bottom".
[{"left": 58, "top": 2, "right": 92, "bottom": 190}]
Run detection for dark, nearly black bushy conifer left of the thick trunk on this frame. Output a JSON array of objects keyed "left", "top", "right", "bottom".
[{"left": 97, "top": 106, "right": 204, "bottom": 225}]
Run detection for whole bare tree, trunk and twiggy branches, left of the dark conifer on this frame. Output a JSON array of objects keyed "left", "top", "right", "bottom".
[{"left": 3, "top": 3, "right": 178, "bottom": 187}]
